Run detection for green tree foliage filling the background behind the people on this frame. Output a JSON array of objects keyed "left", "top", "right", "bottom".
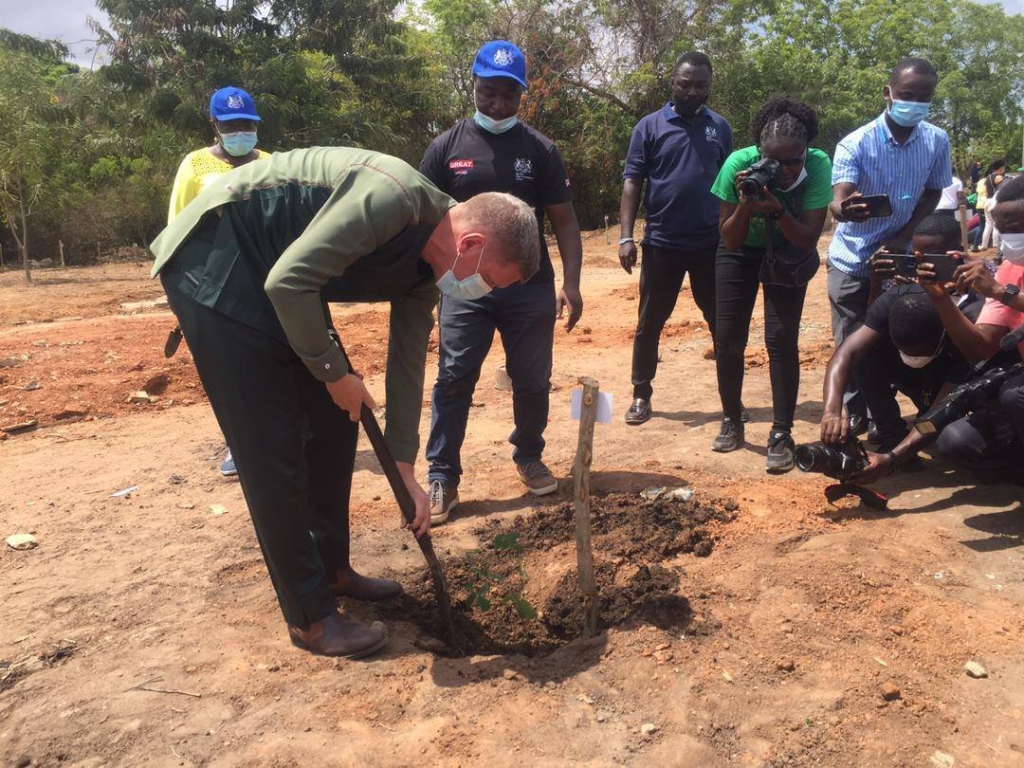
[{"left": 0, "top": 0, "right": 1024, "bottom": 278}]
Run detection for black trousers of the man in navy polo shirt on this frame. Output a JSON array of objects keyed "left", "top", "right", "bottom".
[{"left": 633, "top": 245, "right": 716, "bottom": 400}]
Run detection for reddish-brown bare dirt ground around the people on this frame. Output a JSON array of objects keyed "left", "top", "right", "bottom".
[{"left": 0, "top": 233, "right": 1024, "bottom": 767}]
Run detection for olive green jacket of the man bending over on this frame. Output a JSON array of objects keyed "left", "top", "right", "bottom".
[{"left": 150, "top": 147, "right": 456, "bottom": 462}]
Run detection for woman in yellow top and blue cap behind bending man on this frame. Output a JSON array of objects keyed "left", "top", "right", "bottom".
[{"left": 167, "top": 87, "right": 270, "bottom": 477}]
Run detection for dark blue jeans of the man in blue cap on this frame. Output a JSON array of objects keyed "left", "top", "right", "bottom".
[{"left": 427, "top": 283, "right": 555, "bottom": 486}]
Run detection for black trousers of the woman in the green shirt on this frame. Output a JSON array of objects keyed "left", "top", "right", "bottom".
[{"left": 715, "top": 249, "right": 807, "bottom": 432}]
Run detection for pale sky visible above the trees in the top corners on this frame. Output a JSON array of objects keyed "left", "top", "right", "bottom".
[{"left": 0, "top": 0, "right": 1024, "bottom": 67}]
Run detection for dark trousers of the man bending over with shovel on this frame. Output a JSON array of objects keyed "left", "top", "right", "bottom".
[{"left": 164, "top": 280, "right": 358, "bottom": 628}]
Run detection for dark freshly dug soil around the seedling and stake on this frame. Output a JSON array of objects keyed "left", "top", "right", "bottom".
[{"left": 376, "top": 494, "right": 735, "bottom": 655}]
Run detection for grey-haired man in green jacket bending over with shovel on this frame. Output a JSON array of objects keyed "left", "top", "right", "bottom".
[{"left": 151, "top": 147, "right": 540, "bottom": 657}]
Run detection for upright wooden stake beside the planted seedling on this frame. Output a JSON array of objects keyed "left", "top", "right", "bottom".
[{"left": 572, "top": 377, "right": 599, "bottom": 637}]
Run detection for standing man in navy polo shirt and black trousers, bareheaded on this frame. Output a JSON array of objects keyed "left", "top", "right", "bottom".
[{"left": 618, "top": 51, "right": 732, "bottom": 425}]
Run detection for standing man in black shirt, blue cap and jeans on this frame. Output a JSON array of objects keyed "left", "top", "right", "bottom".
[{"left": 420, "top": 40, "right": 583, "bottom": 524}]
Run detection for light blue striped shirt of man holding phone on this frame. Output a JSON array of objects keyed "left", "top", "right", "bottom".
[{"left": 828, "top": 113, "right": 952, "bottom": 278}]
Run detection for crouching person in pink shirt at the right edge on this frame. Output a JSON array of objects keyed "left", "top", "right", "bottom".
[{"left": 926, "top": 176, "right": 1024, "bottom": 482}]
